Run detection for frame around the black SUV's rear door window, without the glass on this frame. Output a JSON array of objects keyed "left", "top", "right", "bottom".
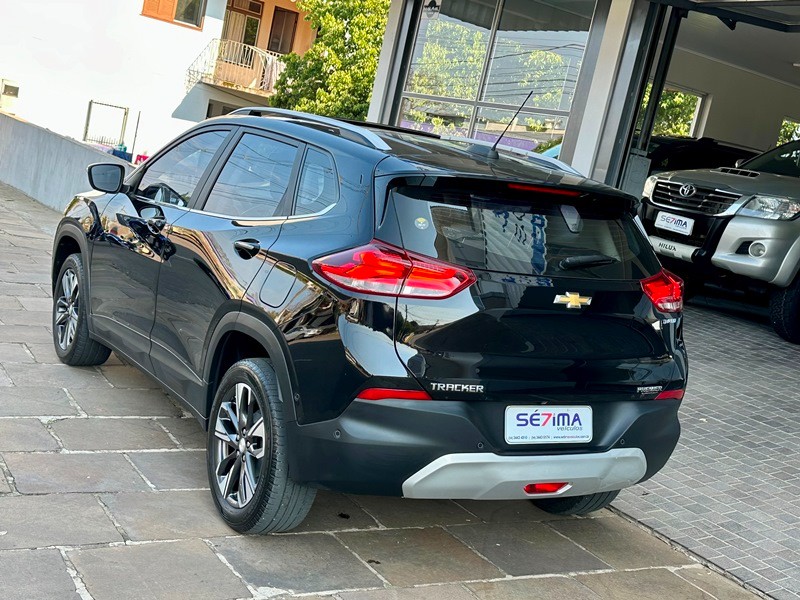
[{"left": 192, "top": 127, "right": 306, "bottom": 223}]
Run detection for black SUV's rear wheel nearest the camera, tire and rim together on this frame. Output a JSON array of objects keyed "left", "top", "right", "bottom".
[{"left": 207, "top": 358, "right": 316, "bottom": 533}]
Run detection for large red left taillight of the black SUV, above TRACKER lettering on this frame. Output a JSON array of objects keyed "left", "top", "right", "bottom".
[{"left": 311, "top": 240, "right": 475, "bottom": 298}]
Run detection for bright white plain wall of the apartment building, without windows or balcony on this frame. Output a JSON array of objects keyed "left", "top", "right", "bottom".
[{"left": 0, "top": 0, "right": 253, "bottom": 154}]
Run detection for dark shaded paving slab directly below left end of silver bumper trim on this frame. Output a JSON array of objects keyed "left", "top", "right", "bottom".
[{"left": 353, "top": 496, "right": 480, "bottom": 527}]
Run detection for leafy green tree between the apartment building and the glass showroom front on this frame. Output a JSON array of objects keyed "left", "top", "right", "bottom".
[{"left": 271, "top": 0, "right": 390, "bottom": 119}]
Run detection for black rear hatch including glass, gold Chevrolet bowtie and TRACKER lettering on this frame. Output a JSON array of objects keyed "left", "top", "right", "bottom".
[{"left": 377, "top": 178, "right": 682, "bottom": 412}]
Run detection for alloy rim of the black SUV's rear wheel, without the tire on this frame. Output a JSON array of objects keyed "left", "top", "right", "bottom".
[{"left": 212, "top": 383, "right": 269, "bottom": 508}]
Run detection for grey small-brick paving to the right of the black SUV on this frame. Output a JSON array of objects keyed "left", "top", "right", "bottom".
[{"left": 614, "top": 298, "right": 800, "bottom": 599}]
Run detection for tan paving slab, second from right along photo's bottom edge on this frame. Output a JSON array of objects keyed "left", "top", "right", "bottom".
[{"left": 575, "top": 569, "right": 712, "bottom": 600}]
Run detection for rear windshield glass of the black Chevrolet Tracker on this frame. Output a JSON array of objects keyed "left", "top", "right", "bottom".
[{"left": 391, "top": 187, "right": 661, "bottom": 279}]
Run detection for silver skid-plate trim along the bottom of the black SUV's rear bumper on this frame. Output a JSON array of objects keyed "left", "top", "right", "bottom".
[{"left": 403, "top": 448, "right": 647, "bottom": 500}]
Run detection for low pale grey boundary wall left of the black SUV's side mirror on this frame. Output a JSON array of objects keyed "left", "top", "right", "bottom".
[{"left": 0, "top": 112, "right": 131, "bottom": 211}]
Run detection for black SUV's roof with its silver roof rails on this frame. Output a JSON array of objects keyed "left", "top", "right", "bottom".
[{"left": 204, "top": 107, "right": 628, "bottom": 197}]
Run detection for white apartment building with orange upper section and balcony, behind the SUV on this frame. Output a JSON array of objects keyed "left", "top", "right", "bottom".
[{"left": 0, "top": 0, "right": 315, "bottom": 154}]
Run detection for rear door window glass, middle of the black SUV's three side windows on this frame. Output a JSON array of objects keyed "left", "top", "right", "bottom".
[{"left": 203, "top": 133, "right": 297, "bottom": 219}]
